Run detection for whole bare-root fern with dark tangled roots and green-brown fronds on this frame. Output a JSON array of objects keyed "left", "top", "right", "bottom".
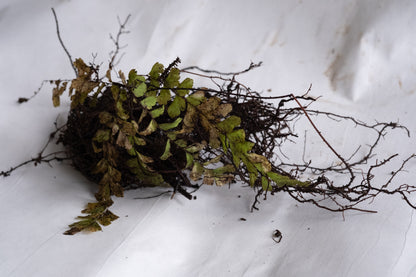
[{"left": 1, "top": 12, "right": 416, "bottom": 235}]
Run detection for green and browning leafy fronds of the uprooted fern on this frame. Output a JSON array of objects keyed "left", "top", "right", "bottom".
[{"left": 52, "top": 59, "right": 310, "bottom": 235}]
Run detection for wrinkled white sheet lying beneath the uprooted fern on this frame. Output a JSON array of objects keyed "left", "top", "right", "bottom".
[{"left": 0, "top": 0, "right": 416, "bottom": 277}]
